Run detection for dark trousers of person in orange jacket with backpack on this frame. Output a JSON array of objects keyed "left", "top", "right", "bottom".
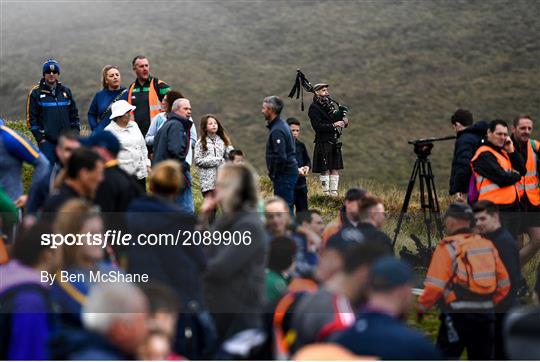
[{"left": 437, "top": 312, "right": 495, "bottom": 360}]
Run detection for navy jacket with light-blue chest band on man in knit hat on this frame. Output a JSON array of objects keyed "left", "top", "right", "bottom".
[{"left": 26, "top": 79, "right": 81, "bottom": 144}]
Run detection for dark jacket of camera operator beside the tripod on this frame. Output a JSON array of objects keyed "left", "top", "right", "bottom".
[{"left": 450, "top": 121, "right": 489, "bottom": 195}]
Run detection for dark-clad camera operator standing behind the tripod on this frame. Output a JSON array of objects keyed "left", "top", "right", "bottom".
[{"left": 450, "top": 109, "right": 488, "bottom": 202}]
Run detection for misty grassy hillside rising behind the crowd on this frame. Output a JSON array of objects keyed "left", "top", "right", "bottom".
[{"left": 0, "top": 0, "right": 540, "bottom": 186}]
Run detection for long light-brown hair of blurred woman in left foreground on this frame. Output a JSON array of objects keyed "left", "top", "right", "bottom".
[{"left": 53, "top": 199, "right": 101, "bottom": 268}]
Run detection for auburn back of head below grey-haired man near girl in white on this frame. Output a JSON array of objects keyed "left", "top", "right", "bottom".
[{"left": 150, "top": 160, "right": 184, "bottom": 196}]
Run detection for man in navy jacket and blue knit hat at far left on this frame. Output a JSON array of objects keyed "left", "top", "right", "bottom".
[{"left": 26, "top": 59, "right": 81, "bottom": 164}]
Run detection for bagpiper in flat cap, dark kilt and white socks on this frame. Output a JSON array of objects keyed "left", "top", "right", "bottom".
[{"left": 308, "top": 83, "right": 349, "bottom": 196}]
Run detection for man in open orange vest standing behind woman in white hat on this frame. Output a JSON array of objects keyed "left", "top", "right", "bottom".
[{"left": 128, "top": 55, "right": 171, "bottom": 135}]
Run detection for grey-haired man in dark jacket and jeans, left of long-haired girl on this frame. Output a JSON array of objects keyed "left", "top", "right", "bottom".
[{"left": 152, "top": 98, "right": 195, "bottom": 214}]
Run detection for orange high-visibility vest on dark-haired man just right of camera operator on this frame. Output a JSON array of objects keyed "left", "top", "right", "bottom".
[{"left": 471, "top": 146, "right": 518, "bottom": 205}]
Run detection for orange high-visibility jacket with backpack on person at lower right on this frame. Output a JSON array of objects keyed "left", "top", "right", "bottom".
[{"left": 418, "top": 233, "right": 510, "bottom": 310}]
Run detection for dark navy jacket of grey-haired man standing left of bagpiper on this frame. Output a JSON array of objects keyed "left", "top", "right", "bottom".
[{"left": 266, "top": 117, "right": 298, "bottom": 179}]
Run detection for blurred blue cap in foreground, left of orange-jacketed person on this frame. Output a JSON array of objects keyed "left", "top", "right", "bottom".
[{"left": 369, "top": 256, "right": 414, "bottom": 290}]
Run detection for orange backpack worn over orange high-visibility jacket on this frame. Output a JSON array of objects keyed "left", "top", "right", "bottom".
[{"left": 449, "top": 235, "right": 497, "bottom": 299}]
